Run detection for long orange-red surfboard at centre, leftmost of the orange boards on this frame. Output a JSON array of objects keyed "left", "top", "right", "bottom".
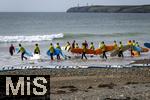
[{"left": 71, "top": 48, "right": 95, "bottom": 54}]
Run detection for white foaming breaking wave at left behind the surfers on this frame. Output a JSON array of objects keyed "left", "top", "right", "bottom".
[{"left": 0, "top": 33, "right": 64, "bottom": 43}]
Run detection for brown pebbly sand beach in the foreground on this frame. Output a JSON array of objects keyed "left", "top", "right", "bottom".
[{"left": 0, "top": 62, "right": 150, "bottom": 100}]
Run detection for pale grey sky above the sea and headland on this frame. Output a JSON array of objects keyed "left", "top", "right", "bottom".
[{"left": 0, "top": 0, "right": 150, "bottom": 12}]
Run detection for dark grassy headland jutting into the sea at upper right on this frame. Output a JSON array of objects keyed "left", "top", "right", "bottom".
[{"left": 67, "top": 5, "right": 150, "bottom": 13}]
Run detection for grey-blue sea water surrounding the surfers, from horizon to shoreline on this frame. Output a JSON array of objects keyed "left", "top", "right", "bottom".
[{"left": 0, "top": 12, "right": 150, "bottom": 69}]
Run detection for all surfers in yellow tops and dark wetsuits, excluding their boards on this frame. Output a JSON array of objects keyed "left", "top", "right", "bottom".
[{"left": 9, "top": 40, "right": 140, "bottom": 60}]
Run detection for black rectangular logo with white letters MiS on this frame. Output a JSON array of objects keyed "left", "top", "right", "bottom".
[{"left": 0, "top": 75, "right": 50, "bottom": 100}]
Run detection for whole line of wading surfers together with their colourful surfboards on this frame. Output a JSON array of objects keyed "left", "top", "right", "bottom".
[{"left": 9, "top": 40, "right": 150, "bottom": 61}]
